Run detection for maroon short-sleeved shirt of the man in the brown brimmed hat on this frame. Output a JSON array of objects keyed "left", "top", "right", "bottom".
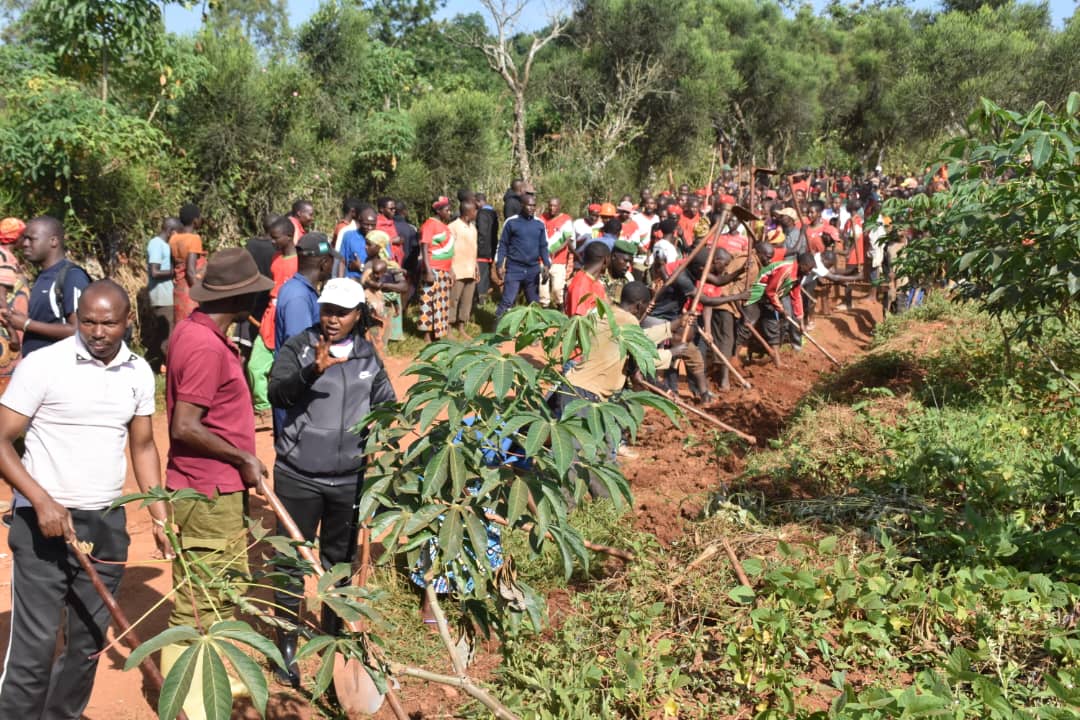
[{"left": 165, "top": 310, "right": 255, "bottom": 497}]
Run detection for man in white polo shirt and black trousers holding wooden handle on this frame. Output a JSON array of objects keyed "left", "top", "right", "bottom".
[{"left": 0, "top": 281, "right": 172, "bottom": 720}]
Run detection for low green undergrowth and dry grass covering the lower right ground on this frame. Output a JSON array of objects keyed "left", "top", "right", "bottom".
[{"left": 477, "top": 299, "right": 1080, "bottom": 720}]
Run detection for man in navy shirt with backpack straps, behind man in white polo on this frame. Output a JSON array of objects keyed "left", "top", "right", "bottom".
[{"left": 9, "top": 215, "right": 90, "bottom": 357}]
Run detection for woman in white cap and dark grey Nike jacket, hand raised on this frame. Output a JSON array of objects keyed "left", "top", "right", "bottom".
[{"left": 268, "top": 277, "right": 396, "bottom": 687}]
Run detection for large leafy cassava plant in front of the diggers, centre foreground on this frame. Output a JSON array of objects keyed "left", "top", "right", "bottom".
[{"left": 360, "top": 302, "right": 675, "bottom": 636}]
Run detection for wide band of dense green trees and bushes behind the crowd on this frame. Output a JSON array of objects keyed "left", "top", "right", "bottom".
[{"left": 0, "top": 0, "right": 1080, "bottom": 258}]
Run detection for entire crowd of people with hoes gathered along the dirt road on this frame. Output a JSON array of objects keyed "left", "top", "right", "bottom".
[{"left": 0, "top": 162, "right": 944, "bottom": 718}]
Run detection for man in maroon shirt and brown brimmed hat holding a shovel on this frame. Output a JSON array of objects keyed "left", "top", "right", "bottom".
[{"left": 162, "top": 247, "right": 273, "bottom": 690}]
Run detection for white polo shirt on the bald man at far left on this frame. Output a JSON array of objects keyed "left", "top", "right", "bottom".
[{"left": 0, "top": 334, "right": 154, "bottom": 510}]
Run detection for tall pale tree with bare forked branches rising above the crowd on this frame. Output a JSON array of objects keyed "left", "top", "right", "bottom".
[{"left": 464, "top": 0, "right": 567, "bottom": 181}]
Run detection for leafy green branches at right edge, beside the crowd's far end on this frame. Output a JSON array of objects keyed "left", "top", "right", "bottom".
[{"left": 885, "top": 93, "right": 1080, "bottom": 339}]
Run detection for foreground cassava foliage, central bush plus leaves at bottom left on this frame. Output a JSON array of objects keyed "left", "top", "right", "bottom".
[{"left": 116, "top": 301, "right": 675, "bottom": 719}]
